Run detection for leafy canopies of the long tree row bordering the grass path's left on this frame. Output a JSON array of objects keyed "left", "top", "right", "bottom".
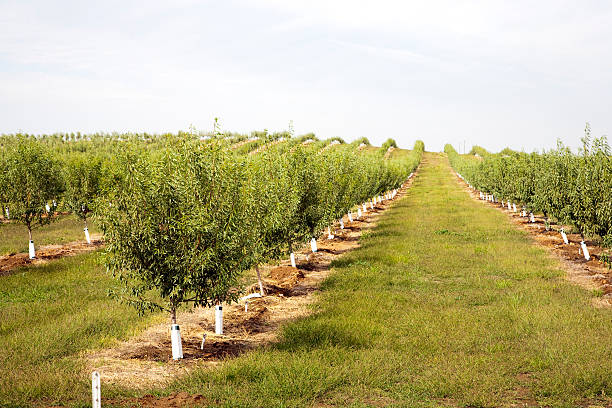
[{"left": 96, "top": 140, "right": 423, "bottom": 316}]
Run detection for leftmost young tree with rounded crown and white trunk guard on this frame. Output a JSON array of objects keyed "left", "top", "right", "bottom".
[{"left": 0, "top": 137, "right": 62, "bottom": 258}]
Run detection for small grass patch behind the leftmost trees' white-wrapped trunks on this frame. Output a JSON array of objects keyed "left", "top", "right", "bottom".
[{"left": 0, "top": 215, "right": 99, "bottom": 255}]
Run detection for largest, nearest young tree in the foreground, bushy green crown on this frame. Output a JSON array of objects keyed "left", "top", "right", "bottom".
[{"left": 96, "top": 140, "right": 255, "bottom": 358}]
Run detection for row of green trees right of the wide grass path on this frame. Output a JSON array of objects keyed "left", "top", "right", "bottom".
[{"left": 445, "top": 124, "right": 612, "bottom": 246}]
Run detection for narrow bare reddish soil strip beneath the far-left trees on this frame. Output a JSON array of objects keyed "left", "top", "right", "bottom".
[{"left": 0, "top": 234, "right": 104, "bottom": 276}]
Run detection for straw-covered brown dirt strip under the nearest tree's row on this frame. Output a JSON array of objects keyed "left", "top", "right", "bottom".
[{"left": 82, "top": 170, "right": 418, "bottom": 408}]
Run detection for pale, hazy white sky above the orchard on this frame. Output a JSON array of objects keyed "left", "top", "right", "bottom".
[{"left": 0, "top": 0, "right": 612, "bottom": 151}]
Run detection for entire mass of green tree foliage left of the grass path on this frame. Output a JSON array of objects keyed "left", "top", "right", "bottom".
[{"left": 0, "top": 134, "right": 424, "bottom": 348}]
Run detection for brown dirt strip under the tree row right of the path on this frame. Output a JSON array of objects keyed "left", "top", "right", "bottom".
[{"left": 451, "top": 170, "right": 612, "bottom": 307}]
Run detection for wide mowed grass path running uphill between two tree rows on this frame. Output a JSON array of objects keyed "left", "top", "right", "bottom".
[{"left": 165, "top": 154, "right": 612, "bottom": 407}]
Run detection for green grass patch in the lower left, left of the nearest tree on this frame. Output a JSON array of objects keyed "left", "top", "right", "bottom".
[{"left": 0, "top": 252, "right": 157, "bottom": 407}]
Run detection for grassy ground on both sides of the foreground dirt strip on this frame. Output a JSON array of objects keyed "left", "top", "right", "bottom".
[{"left": 0, "top": 154, "right": 612, "bottom": 407}]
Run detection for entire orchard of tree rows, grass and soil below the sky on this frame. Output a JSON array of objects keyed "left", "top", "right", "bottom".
[{"left": 0, "top": 129, "right": 612, "bottom": 407}]
